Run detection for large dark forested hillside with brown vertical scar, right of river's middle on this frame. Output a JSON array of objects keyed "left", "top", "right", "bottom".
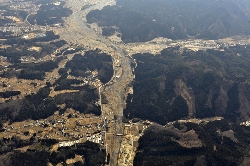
[{"left": 124, "top": 46, "right": 250, "bottom": 124}]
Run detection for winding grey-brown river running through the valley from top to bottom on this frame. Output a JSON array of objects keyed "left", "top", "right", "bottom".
[{"left": 73, "top": 0, "right": 133, "bottom": 166}]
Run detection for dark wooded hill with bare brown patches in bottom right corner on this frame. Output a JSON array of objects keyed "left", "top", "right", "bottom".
[{"left": 134, "top": 120, "right": 250, "bottom": 166}]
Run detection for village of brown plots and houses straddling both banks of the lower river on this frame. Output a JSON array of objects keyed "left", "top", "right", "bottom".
[{"left": 0, "top": 106, "right": 150, "bottom": 156}]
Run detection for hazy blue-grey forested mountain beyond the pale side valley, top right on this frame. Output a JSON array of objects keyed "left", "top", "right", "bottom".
[{"left": 87, "top": 0, "right": 250, "bottom": 42}]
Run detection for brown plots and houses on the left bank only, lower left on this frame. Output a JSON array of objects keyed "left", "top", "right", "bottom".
[{"left": 0, "top": 112, "right": 107, "bottom": 144}]
